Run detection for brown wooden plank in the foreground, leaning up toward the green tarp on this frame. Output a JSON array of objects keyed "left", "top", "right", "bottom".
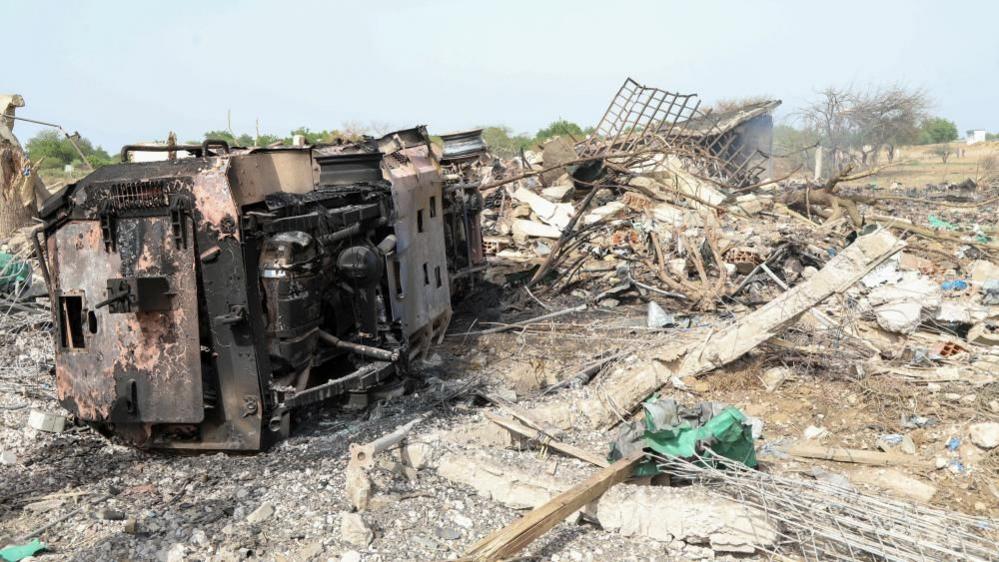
[{"left": 463, "top": 451, "right": 645, "bottom": 560}]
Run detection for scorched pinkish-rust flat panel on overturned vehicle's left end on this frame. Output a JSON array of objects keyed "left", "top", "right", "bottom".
[{"left": 54, "top": 216, "right": 204, "bottom": 423}]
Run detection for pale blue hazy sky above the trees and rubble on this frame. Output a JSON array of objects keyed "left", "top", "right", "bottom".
[{"left": 0, "top": 0, "right": 999, "bottom": 152}]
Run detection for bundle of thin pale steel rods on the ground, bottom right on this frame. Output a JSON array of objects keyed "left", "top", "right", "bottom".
[{"left": 655, "top": 450, "right": 999, "bottom": 561}]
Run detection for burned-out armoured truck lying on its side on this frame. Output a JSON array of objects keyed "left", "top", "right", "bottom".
[{"left": 39, "top": 127, "right": 482, "bottom": 451}]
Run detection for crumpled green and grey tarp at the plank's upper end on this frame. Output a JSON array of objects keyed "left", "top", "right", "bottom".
[{"left": 609, "top": 396, "right": 756, "bottom": 476}]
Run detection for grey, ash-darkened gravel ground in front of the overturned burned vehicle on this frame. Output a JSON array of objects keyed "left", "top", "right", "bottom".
[{"left": 0, "top": 316, "right": 680, "bottom": 561}]
